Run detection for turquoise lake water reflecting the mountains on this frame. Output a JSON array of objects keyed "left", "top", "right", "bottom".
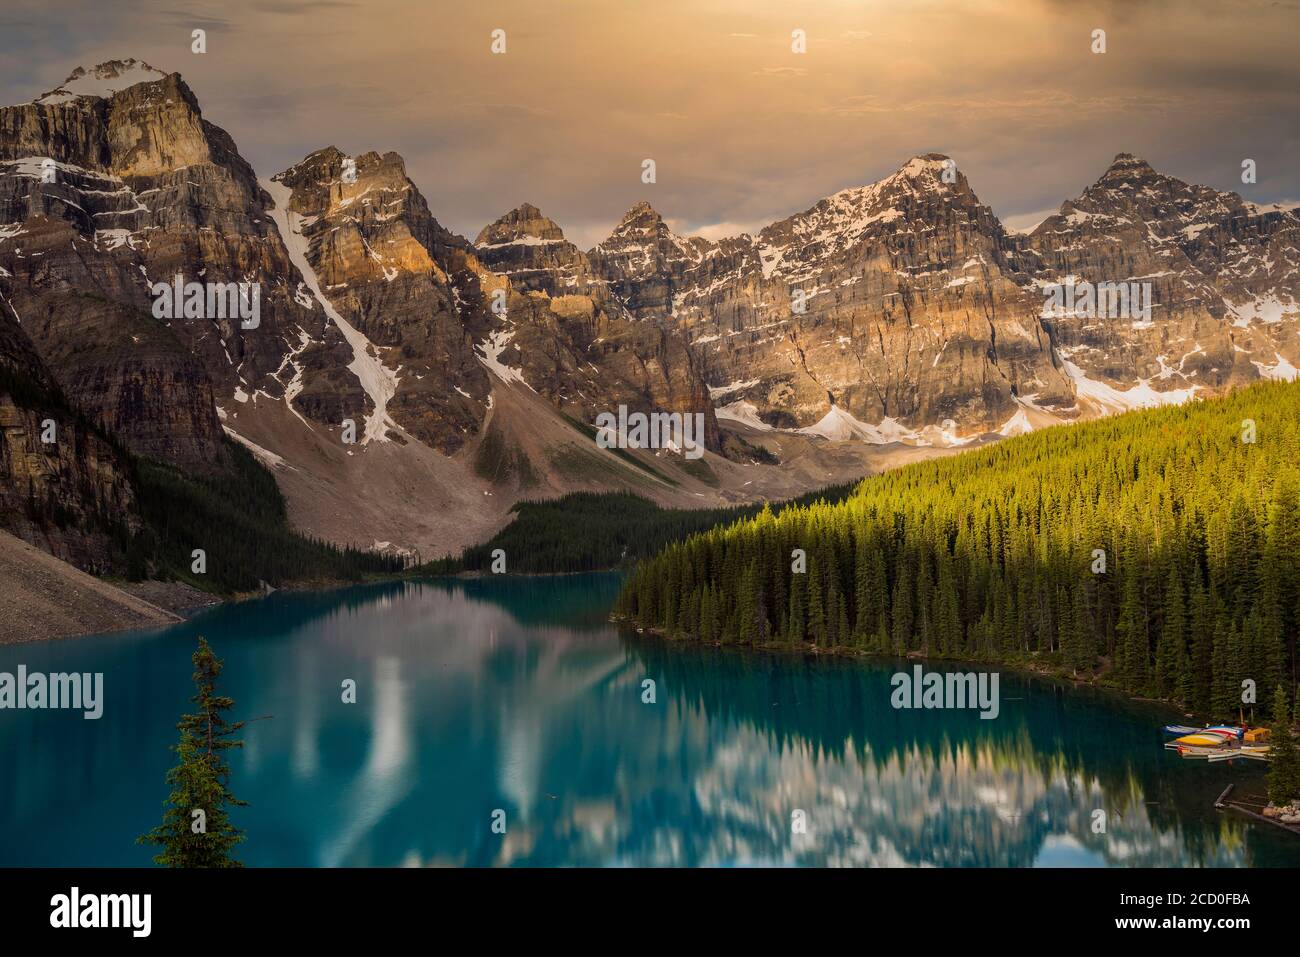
[{"left": 0, "top": 575, "right": 1300, "bottom": 866}]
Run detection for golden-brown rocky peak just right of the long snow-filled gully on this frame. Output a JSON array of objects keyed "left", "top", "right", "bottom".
[{"left": 273, "top": 147, "right": 490, "bottom": 452}]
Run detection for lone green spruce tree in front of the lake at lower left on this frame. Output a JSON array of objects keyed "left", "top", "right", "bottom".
[{"left": 137, "top": 637, "right": 246, "bottom": 867}]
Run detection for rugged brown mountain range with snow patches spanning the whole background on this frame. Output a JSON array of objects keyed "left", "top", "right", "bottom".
[{"left": 0, "top": 60, "right": 1300, "bottom": 570}]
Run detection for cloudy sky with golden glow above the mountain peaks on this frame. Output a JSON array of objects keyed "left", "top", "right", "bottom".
[{"left": 0, "top": 0, "right": 1300, "bottom": 248}]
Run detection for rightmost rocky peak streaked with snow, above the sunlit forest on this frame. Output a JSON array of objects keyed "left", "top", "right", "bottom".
[{"left": 1027, "top": 153, "right": 1300, "bottom": 411}]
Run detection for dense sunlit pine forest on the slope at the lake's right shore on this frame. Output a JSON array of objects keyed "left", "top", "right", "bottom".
[{"left": 616, "top": 382, "right": 1300, "bottom": 718}]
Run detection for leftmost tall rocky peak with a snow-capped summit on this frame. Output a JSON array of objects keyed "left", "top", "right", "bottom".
[{"left": 0, "top": 61, "right": 330, "bottom": 468}]
